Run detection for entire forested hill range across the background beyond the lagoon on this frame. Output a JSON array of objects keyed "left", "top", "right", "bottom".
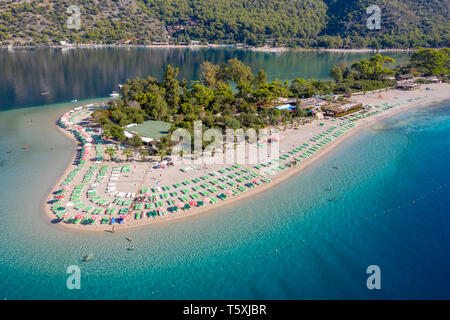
[{"left": 0, "top": 0, "right": 450, "bottom": 48}]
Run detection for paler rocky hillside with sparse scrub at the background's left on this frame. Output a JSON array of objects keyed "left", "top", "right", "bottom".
[{"left": 0, "top": 0, "right": 167, "bottom": 45}]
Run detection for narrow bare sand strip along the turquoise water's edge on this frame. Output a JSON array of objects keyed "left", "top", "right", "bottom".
[{"left": 43, "top": 84, "right": 450, "bottom": 232}]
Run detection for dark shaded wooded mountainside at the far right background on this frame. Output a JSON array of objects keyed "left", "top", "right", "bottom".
[{"left": 323, "top": 0, "right": 450, "bottom": 47}]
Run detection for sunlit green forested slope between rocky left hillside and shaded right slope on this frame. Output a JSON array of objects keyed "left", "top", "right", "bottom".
[{"left": 142, "top": 0, "right": 327, "bottom": 45}]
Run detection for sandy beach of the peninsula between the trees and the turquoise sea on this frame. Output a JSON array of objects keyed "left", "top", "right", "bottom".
[{"left": 44, "top": 84, "right": 450, "bottom": 232}]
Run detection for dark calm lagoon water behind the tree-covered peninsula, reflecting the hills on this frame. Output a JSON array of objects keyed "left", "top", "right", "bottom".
[{"left": 0, "top": 48, "right": 409, "bottom": 109}]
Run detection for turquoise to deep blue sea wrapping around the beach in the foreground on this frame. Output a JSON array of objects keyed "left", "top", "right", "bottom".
[{"left": 0, "top": 48, "right": 450, "bottom": 299}]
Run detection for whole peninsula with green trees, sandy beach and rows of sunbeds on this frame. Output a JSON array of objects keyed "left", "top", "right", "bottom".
[{"left": 45, "top": 49, "right": 450, "bottom": 231}]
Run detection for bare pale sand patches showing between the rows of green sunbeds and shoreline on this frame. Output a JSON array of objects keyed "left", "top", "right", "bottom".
[{"left": 45, "top": 84, "right": 450, "bottom": 231}]
